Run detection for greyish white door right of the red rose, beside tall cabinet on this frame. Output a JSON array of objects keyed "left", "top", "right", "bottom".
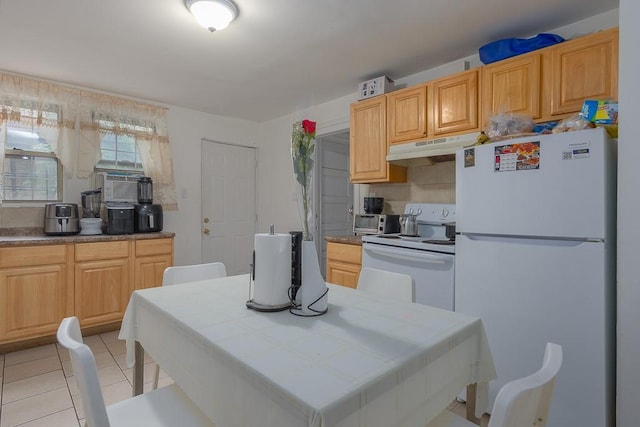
[{"left": 316, "top": 131, "right": 353, "bottom": 275}]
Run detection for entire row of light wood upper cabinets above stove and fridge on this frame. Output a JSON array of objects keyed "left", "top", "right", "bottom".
[{"left": 350, "top": 28, "right": 618, "bottom": 183}]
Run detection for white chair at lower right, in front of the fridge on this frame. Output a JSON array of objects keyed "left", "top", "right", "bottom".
[{"left": 427, "top": 343, "right": 562, "bottom": 427}]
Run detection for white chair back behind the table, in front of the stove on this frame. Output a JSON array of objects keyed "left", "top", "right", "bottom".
[{"left": 357, "top": 268, "right": 416, "bottom": 302}]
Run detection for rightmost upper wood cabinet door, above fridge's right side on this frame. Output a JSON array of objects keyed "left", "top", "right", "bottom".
[{"left": 548, "top": 28, "right": 618, "bottom": 119}]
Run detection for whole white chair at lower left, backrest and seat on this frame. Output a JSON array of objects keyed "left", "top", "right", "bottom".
[{"left": 57, "top": 317, "right": 215, "bottom": 427}]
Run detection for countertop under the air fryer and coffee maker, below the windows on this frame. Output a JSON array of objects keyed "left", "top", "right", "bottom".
[{"left": 0, "top": 228, "right": 175, "bottom": 247}]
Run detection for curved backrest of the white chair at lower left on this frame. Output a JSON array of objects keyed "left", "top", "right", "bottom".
[{"left": 57, "top": 317, "right": 110, "bottom": 427}]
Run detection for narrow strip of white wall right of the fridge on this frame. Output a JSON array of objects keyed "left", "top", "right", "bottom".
[{"left": 617, "top": 0, "right": 640, "bottom": 427}]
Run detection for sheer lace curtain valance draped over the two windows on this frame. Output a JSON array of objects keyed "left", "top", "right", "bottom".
[{"left": 0, "top": 73, "right": 178, "bottom": 210}]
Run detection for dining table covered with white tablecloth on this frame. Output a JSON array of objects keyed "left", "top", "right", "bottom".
[{"left": 119, "top": 275, "right": 496, "bottom": 427}]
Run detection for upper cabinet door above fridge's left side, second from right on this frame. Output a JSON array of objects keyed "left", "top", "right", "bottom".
[{"left": 481, "top": 52, "right": 542, "bottom": 127}]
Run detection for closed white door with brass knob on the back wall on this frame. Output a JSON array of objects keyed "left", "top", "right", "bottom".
[{"left": 201, "top": 139, "right": 256, "bottom": 275}]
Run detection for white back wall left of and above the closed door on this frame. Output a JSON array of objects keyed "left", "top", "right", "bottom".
[{"left": 164, "top": 107, "right": 259, "bottom": 265}]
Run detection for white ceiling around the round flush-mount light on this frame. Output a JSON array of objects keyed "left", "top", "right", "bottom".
[{"left": 0, "top": 0, "right": 619, "bottom": 122}]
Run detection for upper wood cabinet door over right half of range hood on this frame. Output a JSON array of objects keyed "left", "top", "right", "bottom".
[{"left": 429, "top": 68, "right": 480, "bottom": 136}]
